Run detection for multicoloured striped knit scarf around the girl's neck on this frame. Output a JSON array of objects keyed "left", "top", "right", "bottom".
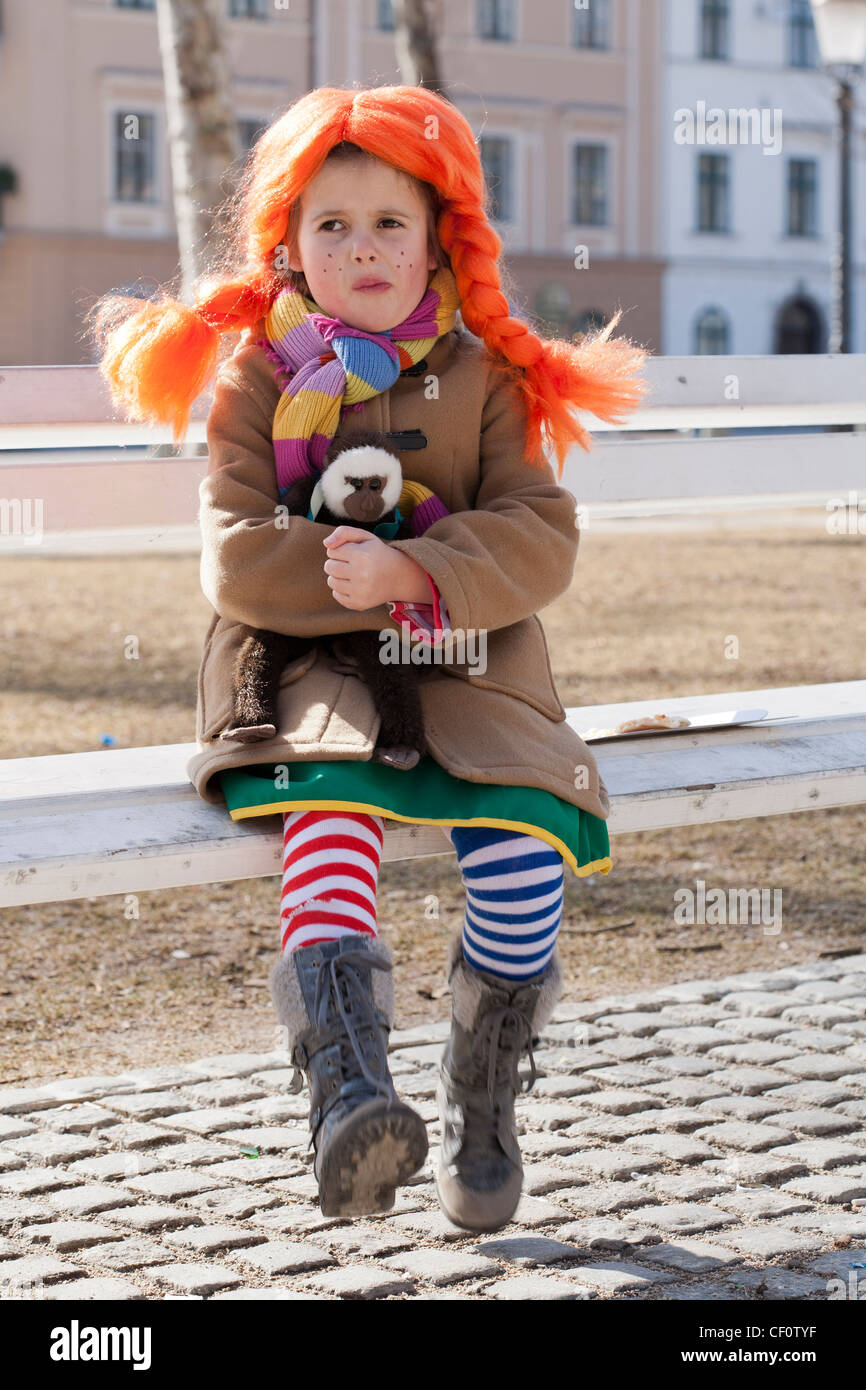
[{"left": 264, "top": 265, "right": 460, "bottom": 535}]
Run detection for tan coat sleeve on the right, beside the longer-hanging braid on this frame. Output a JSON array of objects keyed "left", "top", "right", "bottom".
[{"left": 391, "top": 371, "right": 578, "bottom": 631}]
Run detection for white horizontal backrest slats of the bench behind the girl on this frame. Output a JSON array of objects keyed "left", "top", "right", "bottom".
[{"left": 0, "top": 354, "right": 866, "bottom": 549}]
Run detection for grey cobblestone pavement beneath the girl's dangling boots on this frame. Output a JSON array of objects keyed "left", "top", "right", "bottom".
[{"left": 0, "top": 955, "right": 866, "bottom": 1301}]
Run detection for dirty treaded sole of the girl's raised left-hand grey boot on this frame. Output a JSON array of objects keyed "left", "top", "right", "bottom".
[{"left": 318, "top": 1099, "right": 428, "bottom": 1216}]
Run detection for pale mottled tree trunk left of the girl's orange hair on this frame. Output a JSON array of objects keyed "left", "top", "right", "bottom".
[{"left": 156, "top": 0, "right": 242, "bottom": 303}]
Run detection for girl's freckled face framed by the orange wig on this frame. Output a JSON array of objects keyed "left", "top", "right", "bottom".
[{"left": 289, "top": 160, "right": 436, "bottom": 334}]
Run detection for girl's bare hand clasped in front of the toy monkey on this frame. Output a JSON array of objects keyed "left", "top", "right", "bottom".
[{"left": 324, "top": 525, "right": 430, "bottom": 613}]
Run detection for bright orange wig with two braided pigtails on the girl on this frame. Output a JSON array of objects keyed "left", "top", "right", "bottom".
[{"left": 90, "top": 86, "right": 646, "bottom": 477}]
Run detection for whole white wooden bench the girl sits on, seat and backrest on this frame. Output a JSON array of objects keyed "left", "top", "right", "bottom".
[{"left": 0, "top": 356, "right": 866, "bottom": 905}]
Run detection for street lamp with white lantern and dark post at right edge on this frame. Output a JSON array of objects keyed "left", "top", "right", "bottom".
[{"left": 810, "top": 0, "right": 866, "bottom": 353}]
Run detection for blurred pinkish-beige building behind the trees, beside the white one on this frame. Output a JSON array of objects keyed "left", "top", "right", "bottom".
[{"left": 0, "top": 0, "right": 664, "bottom": 364}]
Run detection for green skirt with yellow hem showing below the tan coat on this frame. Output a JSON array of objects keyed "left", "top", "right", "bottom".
[{"left": 217, "top": 755, "right": 613, "bottom": 878}]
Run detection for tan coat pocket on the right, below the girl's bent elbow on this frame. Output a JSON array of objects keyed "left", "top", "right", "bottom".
[{"left": 442, "top": 614, "right": 566, "bottom": 723}]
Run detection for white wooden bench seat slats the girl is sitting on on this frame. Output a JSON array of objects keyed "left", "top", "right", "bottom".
[{"left": 0, "top": 681, "right": 866, "bottom": 905}]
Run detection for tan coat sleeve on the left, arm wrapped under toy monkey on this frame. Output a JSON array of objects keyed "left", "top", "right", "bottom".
[{"left": 199, "top": 353, "right": 395, "bottom": 637}]
